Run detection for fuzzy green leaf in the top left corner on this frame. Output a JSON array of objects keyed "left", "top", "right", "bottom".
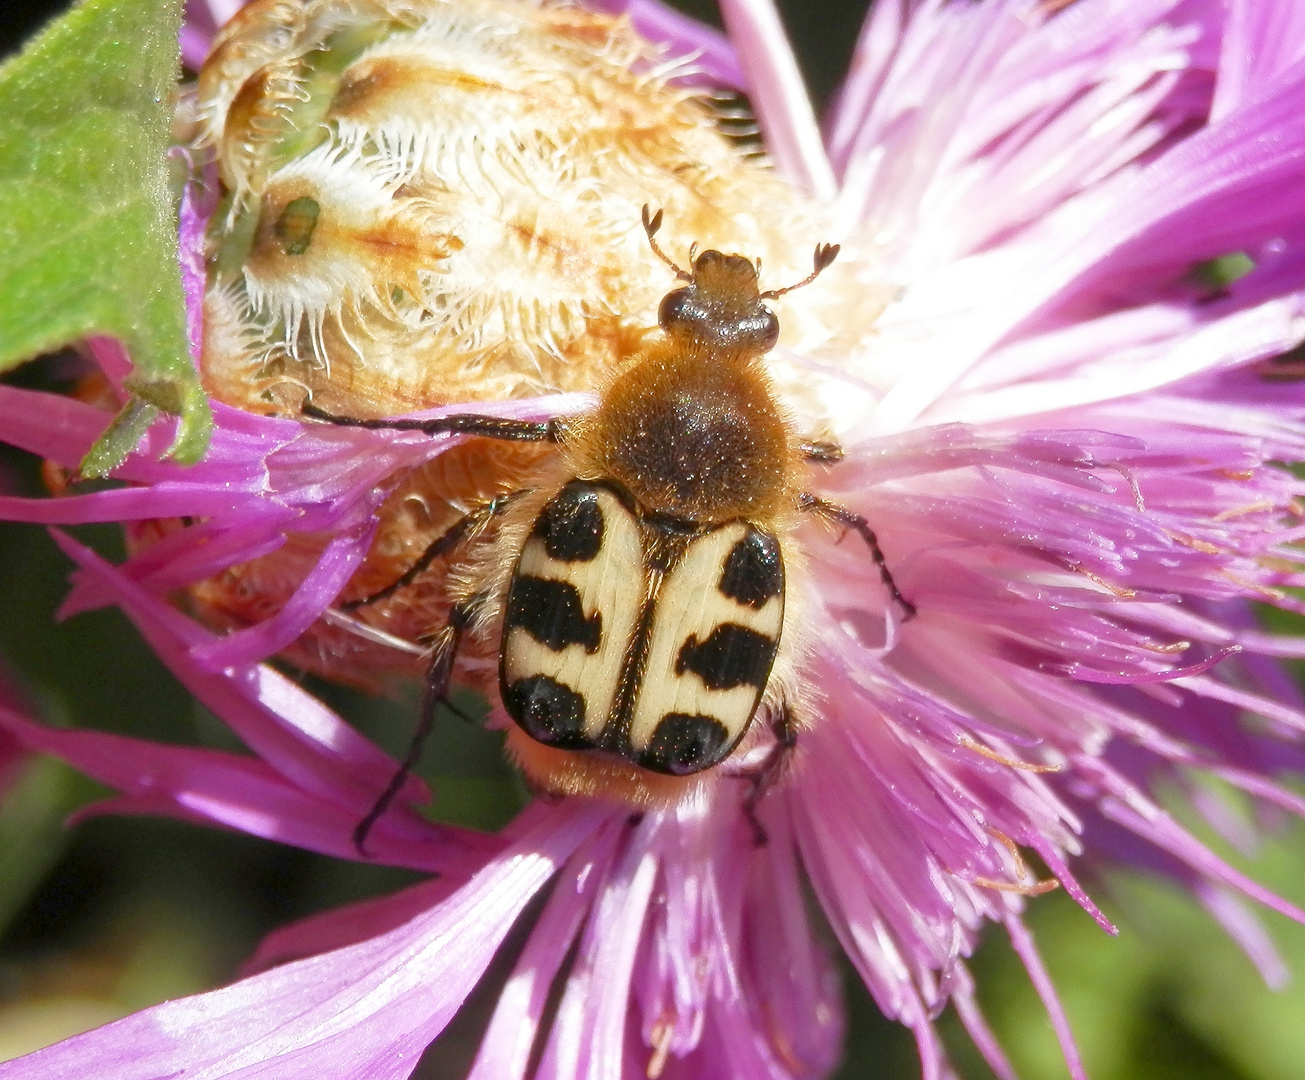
[{"left": 0, "top": 0, "right": 211, "bottom": 462}]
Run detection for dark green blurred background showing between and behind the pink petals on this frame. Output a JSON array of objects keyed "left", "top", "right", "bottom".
[{"left": 0, "top": 0, "right": 1305, "bottom": 1080}]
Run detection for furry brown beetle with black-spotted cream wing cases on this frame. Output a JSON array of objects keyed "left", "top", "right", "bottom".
[{"left": 307, "top": 207, "right": 914, "bottom": 844}]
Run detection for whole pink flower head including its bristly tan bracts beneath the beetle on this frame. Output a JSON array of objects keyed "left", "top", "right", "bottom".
[{"left": 0, "top": 0, "right": 1305, "bottom": 1080}]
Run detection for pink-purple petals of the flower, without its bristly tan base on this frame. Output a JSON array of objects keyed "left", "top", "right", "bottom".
[{"left": 0, "top": 0, "right": 1305, "bottom": 1080}]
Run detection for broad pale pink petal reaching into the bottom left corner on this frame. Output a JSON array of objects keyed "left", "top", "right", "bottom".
[{"left": 0, "top": 802, "right": 602, "bottom": 1080}]
